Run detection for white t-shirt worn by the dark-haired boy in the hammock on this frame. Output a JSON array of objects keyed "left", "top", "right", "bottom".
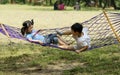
[{"left": 74, "top": 28, "right": 91, "bottom": 50}]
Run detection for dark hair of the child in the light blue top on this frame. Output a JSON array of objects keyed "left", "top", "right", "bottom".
[{"left": 21, "top": 19, "right": 34, "bottom": 36}]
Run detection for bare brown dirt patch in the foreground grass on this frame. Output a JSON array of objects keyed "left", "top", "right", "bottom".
[{"left": 18, "top": 62, "right": 84, "bottom": 75}]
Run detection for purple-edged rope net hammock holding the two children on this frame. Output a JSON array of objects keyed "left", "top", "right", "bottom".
[{"left": 0, "top": 12, "right": 120, "bottom": 49}]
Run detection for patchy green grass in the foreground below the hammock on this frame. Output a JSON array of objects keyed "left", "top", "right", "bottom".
[{"left": 0, "top": 43, "right": 120, "bottom": 75}]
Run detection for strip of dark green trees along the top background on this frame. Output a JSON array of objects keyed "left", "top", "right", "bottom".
[{"left": 0, "top": 0, "right": 120, "bottom": 7}]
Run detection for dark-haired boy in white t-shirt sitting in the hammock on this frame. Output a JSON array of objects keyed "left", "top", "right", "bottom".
[{"left": 57, "top": 23, "right": 90, "bottom": 53}]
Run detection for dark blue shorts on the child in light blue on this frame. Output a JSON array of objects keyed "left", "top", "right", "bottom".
[{"left": 45, "top": 34, "right": 58, "bottom": 44}]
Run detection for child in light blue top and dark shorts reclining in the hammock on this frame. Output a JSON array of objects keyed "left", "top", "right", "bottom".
[{"left": 21, "top": 20, "right": 65, "bottom": 47}]
